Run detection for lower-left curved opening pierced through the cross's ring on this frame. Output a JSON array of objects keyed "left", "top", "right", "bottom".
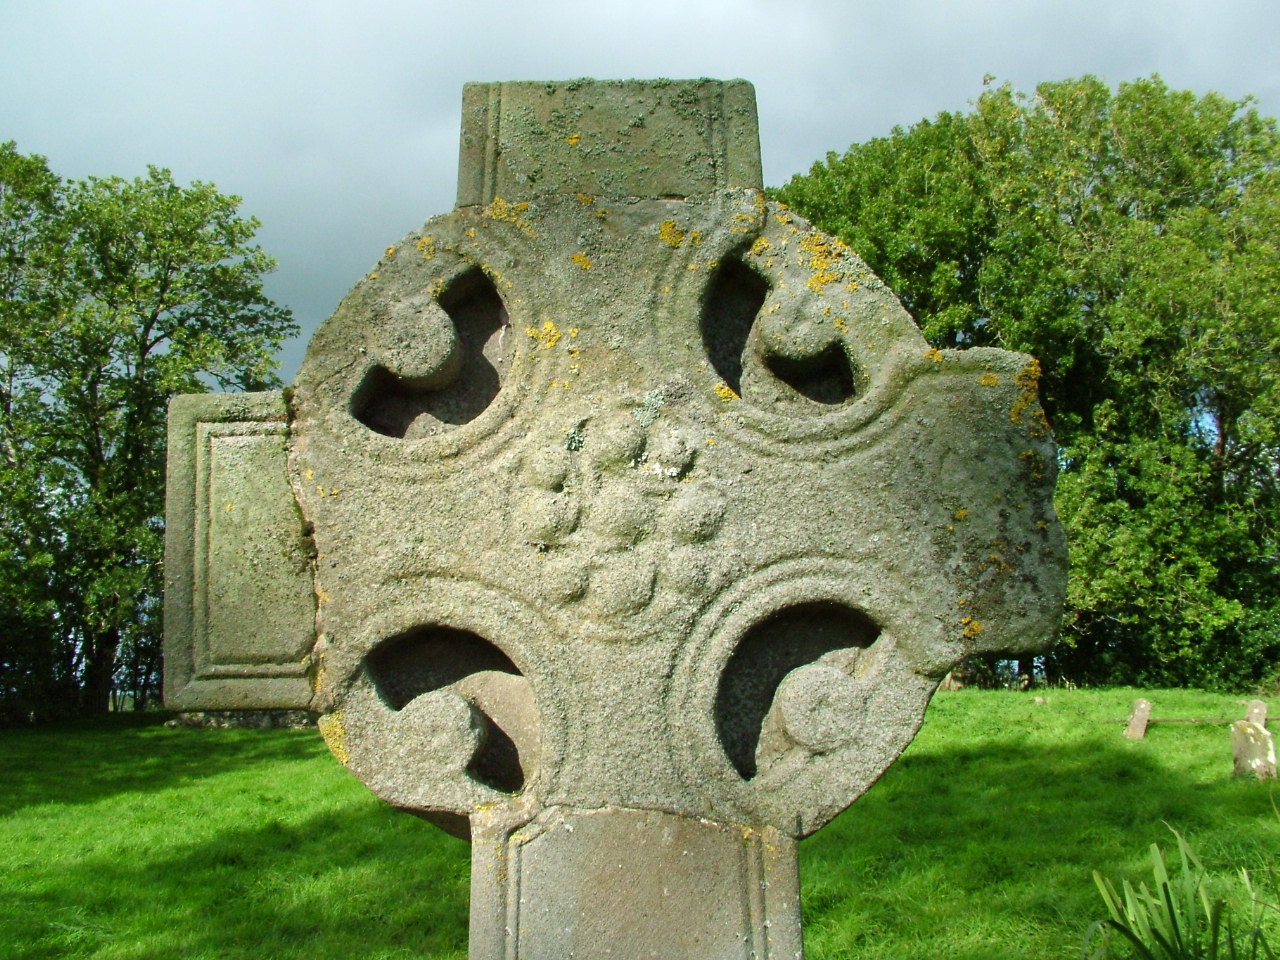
[{"left": 365, "top": 626, "right": 536, "bottom": 792}]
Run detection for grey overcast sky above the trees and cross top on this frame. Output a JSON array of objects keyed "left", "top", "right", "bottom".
[{"left": 0, "top": 0, "right": 1280, "bottom": 380}]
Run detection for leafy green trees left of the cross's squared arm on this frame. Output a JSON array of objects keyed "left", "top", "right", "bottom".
[{"left": 0, "top": 143, "right": 297, "bottom": 713}]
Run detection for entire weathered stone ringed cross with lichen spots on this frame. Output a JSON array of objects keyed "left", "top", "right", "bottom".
[{"left": 165, "top": 81, "right": 1065, "bottom": 960}]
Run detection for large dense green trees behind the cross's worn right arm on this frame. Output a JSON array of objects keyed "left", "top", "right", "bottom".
[{"left": 778, "top": 77, "right": 1280, "bottom": 686}]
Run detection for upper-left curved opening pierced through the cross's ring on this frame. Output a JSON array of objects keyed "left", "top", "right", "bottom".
[{"left": 351, "top": 268, "right": 513, "bottom": 438}]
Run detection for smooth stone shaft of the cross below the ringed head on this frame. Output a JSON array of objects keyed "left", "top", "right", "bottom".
[{"left": 471, "top": 806, "right": 803, "bottom": 960}]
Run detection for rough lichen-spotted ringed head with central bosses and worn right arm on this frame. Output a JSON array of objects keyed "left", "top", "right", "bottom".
[{"left": 291, "top": 135, "right": 1062, "bottom": 836}]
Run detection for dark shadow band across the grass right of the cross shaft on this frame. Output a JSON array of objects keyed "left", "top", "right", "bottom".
[{"left": 801, "top": 739, "right": 1276, "bottom": 881}]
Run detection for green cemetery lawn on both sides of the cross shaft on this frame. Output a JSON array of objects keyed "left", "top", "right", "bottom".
[{"left": 0, "top": 689, "right": 1280, "bottom": 960}]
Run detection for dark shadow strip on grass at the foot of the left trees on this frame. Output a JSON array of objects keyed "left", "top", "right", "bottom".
[{"left": 0, "top": 714, "right": 328, "bottom": 814}]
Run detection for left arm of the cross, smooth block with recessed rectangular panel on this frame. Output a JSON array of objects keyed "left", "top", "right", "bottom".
[{"left": 165, "top": 393, "right": 315, "bottom": 710}]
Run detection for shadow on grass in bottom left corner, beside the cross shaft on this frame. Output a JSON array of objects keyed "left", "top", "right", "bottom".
[{"left": 0, "top": 800, "right": 468, "bottom": 960}]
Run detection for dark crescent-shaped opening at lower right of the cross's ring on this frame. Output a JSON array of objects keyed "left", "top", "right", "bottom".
[{"left": 716, "top": 602, "right": 879, "bottom": 780}]
